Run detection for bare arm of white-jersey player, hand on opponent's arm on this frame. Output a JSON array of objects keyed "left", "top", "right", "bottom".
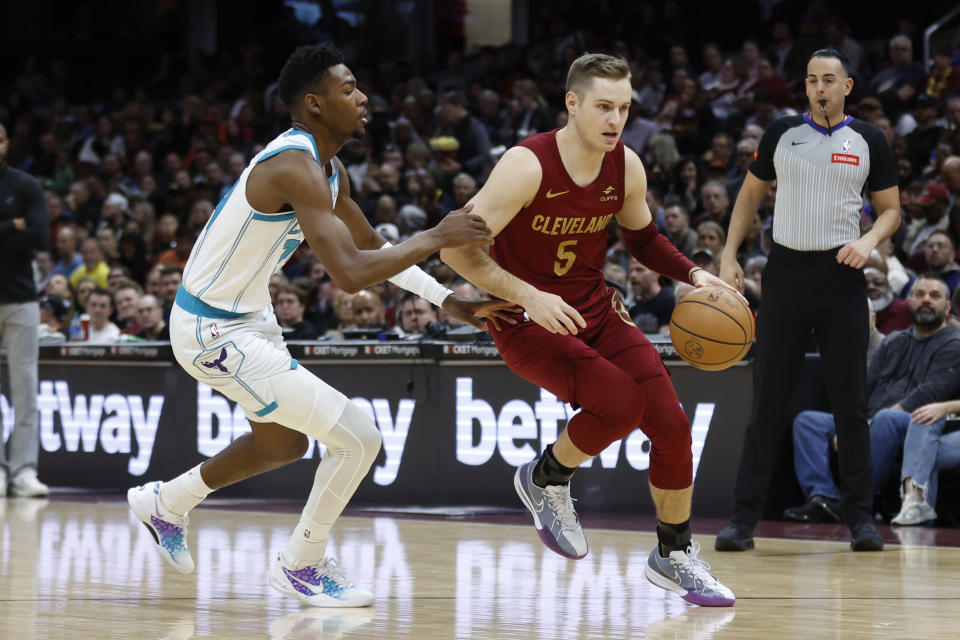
[{"left": 262, "top": 151, "right": 491, "bottom": 292}]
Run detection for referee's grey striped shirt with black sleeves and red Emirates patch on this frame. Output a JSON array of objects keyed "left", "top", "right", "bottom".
[{"left": 750, "top": 113, "right": 897, "bottom": 251}]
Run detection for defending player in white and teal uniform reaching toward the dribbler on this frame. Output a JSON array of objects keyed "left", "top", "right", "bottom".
[{"left": 127, "top": 44, "right": 509, "bottom": 607}]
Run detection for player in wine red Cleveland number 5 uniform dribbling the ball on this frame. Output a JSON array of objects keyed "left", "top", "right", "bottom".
[{"left": 441, "top": 54, "right": 734, "bottom": 606}]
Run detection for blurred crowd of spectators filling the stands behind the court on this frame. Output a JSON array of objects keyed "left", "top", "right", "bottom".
[{"left": 0, "top": 16, "right": 960, "bottom": 348}]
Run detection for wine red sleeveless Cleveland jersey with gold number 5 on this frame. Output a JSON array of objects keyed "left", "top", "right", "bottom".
[{"left": 490, "top": 131, "right": 624, "bottom": 310}]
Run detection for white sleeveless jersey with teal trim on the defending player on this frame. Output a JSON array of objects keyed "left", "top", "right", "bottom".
[{"left": 177, "top": 129, "right": 340, "bottom": 318}]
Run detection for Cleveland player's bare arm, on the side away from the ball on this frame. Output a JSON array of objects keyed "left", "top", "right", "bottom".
[{"left": 440, "top": 147, "right": 586, "bottom": 334}]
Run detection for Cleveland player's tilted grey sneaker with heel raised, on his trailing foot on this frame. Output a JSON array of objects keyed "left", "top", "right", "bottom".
[{"left": 513, "top": 460, "right": 590, "bottom": 560}]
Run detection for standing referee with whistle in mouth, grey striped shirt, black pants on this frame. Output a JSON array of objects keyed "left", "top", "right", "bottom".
[{"left": 716, "top": 49, "right": 900, "bottom": 551}]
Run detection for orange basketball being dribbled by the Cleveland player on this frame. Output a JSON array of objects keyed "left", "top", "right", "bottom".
[{"left": 670, "top": 287, "right": 754, "bottom": 371}]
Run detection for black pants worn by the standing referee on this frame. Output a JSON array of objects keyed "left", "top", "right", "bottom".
[{"left": 733, "top": 245, "right": 873, "bottom": 526}]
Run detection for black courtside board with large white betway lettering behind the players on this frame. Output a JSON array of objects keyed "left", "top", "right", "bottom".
[{"left": 0, "top": 352, "right": 751, "bottom": 517}]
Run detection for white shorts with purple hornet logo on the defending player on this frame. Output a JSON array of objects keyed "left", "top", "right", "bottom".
[{"left": 170, "top": 297, "right": 348, "bottom": 436}]
